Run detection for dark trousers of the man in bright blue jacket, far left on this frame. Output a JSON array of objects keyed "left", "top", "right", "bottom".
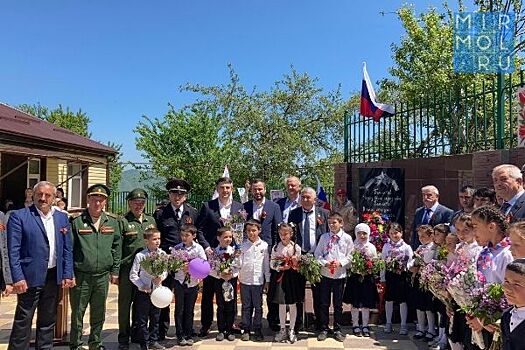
[{"left": 8, "top": 267, "right": 58, "bottom": 350}]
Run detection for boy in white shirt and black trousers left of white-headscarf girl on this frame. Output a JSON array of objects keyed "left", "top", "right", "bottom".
[{"left": 314, "top": 213, "right": 354, "bottom": 342}]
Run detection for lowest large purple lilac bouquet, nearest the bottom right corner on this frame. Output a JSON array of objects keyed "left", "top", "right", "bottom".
[{"left": 461, "top": 283, "right": 510, "bottom": 349}]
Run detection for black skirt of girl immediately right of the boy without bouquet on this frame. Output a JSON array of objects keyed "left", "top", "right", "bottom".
[{"left": 268, "top": 269, "right": 305, "bottom": 304}]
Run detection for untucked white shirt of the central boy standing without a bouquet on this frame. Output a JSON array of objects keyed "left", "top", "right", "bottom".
[{"left": 239, "top": 238, "right": 270, "bottom": 286}]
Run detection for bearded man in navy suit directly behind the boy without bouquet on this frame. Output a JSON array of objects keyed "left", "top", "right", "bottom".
[{"left": 244, "top": 179, "right": 283, "bottom": 331}]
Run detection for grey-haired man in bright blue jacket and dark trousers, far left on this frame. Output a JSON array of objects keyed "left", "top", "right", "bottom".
[{"left": 7, "top": 181, "right": 75, "bottom": 350}]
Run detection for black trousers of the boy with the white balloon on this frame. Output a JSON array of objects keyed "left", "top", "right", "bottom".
[{"left": 132, "top": 290, "right": 160, "bottom": 345}]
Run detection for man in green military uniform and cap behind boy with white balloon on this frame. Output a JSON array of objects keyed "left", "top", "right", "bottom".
[{"left": 118, "top": 188, "right": 156, "bottom": 350}]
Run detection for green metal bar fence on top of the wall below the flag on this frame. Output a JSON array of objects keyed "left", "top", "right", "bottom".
[{"left": 344, "top": 70, "right": 524, "bottom": 163}]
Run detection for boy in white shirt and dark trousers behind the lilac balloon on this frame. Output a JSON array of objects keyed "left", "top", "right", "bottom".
[{"left": 173, "top": 224, "right": 206, "bottom": 346}]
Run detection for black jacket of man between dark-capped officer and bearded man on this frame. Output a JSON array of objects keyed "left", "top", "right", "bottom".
[{"left": 197, "top": 198, "right": 243, "bottom": 249}]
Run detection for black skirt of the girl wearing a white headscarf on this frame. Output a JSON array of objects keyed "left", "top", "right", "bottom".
[{"left": 343, "top": 273, "right": 379, "bottom": 309}]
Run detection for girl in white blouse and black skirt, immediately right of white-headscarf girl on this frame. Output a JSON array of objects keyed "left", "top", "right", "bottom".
[{"left": 381, "top": 222, "right": 413, "bottom": 335}]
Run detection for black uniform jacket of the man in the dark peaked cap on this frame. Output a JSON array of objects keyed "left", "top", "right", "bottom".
[{"left": 155, "top": 203, "right": 206, "bottom": 253}]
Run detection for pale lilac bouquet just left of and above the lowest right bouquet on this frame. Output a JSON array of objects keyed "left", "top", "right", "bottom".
[{"left": 446, "top": 263, "right": 485, "bottom": 349}]
